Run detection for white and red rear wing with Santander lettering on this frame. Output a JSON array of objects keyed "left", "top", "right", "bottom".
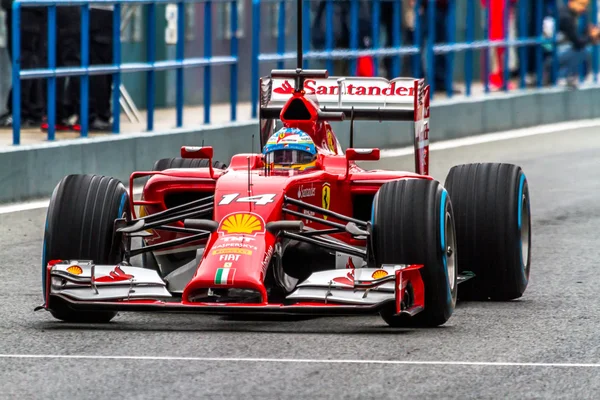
[{"left": 259, "top": 70, "right": 429, "bottom": 175}]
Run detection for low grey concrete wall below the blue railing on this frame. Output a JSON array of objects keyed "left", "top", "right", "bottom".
[{"left": 0, "top": 88, "right": 600, "bottom": 202}]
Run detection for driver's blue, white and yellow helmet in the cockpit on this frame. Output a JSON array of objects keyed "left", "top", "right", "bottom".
[{"left": 263, "top": 128, "right": 317, "bottom": 171}]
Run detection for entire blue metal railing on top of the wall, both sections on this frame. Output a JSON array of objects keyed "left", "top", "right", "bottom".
[{"left": 12, "top": 0, "right": 598, "bottom": 144}]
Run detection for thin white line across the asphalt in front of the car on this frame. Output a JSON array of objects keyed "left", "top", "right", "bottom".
[{"left": 0, "top": 354, "right": 600, "bottom": 368}]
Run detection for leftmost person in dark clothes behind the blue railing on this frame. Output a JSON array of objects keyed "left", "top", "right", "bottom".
[{"left": 0, "top": 0, "right": 47, "bottom": 129}]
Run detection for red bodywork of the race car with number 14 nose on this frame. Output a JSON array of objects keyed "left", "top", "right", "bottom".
[{"left": 47, "top": 76, "right": 432, "bottom": 318}]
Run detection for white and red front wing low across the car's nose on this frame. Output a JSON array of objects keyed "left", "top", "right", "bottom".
[{"left": 42, "top": 260, "right": 425, "bottom": 315}]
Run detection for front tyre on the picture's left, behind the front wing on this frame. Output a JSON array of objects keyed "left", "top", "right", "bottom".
[{"left": 42, "top": 175, "right": 130, "bottom": 322}]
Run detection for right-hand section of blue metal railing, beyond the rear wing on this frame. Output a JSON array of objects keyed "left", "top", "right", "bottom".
[{"left": 251, "top": 0, "right": 598, "bottom": 118}]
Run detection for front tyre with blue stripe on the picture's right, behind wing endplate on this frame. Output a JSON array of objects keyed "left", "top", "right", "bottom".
[{"left": 372, "top": 179, "right": 457, "bottom": 327}]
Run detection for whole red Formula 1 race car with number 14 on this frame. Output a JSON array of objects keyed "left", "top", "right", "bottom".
[{"left": 42, "top": 69, "right": 531, "bottom": 326}]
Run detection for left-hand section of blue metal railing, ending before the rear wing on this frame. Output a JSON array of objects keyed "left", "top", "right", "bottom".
[{"left": 12, "top": 0, "right": 241, "bottom": 145}]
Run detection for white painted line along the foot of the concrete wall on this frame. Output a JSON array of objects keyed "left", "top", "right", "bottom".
[{"left": 0, "top": 115, "right": 600, "bottom": 215}]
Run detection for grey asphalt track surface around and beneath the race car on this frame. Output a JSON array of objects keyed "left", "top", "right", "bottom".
[{"left": 0, "top": 128, "right": 600, "bottom": 399}]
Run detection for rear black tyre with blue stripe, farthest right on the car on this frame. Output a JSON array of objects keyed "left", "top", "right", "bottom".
[{"left": 445, "top": 163, "right": 531, "bottom": 300}]
